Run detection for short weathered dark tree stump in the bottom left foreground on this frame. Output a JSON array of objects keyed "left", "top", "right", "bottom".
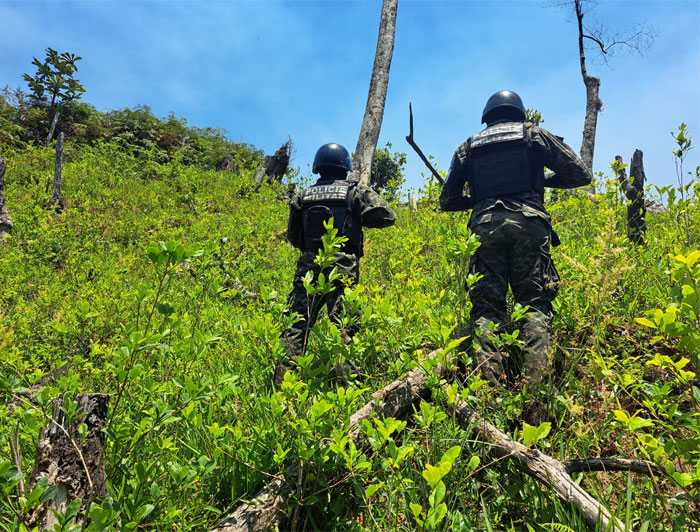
[{"left": 25, "top": 393, "right": 109, "bottom": 530}]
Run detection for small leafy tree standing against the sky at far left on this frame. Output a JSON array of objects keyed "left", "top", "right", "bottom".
[{"left": 24, "top": 48, "right": 85, "bottom": 145}]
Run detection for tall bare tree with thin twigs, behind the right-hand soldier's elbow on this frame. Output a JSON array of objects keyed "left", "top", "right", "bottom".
[{"left": 550, "top": 0, "right": 656, "bottom": 169}]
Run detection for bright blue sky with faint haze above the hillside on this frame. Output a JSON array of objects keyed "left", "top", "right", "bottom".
[{"left": 0, "top": 0, "right": 700, "bottom": 191}]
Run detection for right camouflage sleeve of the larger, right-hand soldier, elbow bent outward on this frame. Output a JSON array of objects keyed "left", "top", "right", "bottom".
[{"left": 534, "top": 128, "right": 593, "bottom": 188}]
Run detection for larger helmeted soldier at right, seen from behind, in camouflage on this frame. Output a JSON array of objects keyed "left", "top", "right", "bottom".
[{"left": 440, "top": 91, "right": 593, "bottom": 386}]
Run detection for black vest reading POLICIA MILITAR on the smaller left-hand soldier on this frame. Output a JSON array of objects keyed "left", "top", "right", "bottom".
[{"left": 300, "top": 181, "right": 362, "bottom": 256}]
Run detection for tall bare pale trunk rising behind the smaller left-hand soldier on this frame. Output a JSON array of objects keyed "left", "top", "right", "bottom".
[{"left": 351, "top": 0, "right": 399, "bottom": 185}]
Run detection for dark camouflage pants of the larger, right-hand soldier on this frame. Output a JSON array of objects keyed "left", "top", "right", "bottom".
[{"left": 470, "top": 209, "right": 559, "bottom": 384}]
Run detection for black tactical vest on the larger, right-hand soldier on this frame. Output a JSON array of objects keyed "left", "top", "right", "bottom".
[{"left": 468, "top": 122, "right": 544, "bottom": 203}]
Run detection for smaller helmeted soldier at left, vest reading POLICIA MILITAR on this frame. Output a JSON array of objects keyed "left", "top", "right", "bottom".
[{"left": 274, "top": 144, "right": 396, "bottom": 388}]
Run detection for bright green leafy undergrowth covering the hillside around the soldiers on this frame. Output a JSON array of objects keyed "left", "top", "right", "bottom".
[{"left": 0, "top": 122, "right": 700, "bottom": 531}]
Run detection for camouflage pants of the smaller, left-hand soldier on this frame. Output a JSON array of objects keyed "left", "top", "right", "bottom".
[{"left": 274, "top": 253, "right": 360, "bottom": 384}]
